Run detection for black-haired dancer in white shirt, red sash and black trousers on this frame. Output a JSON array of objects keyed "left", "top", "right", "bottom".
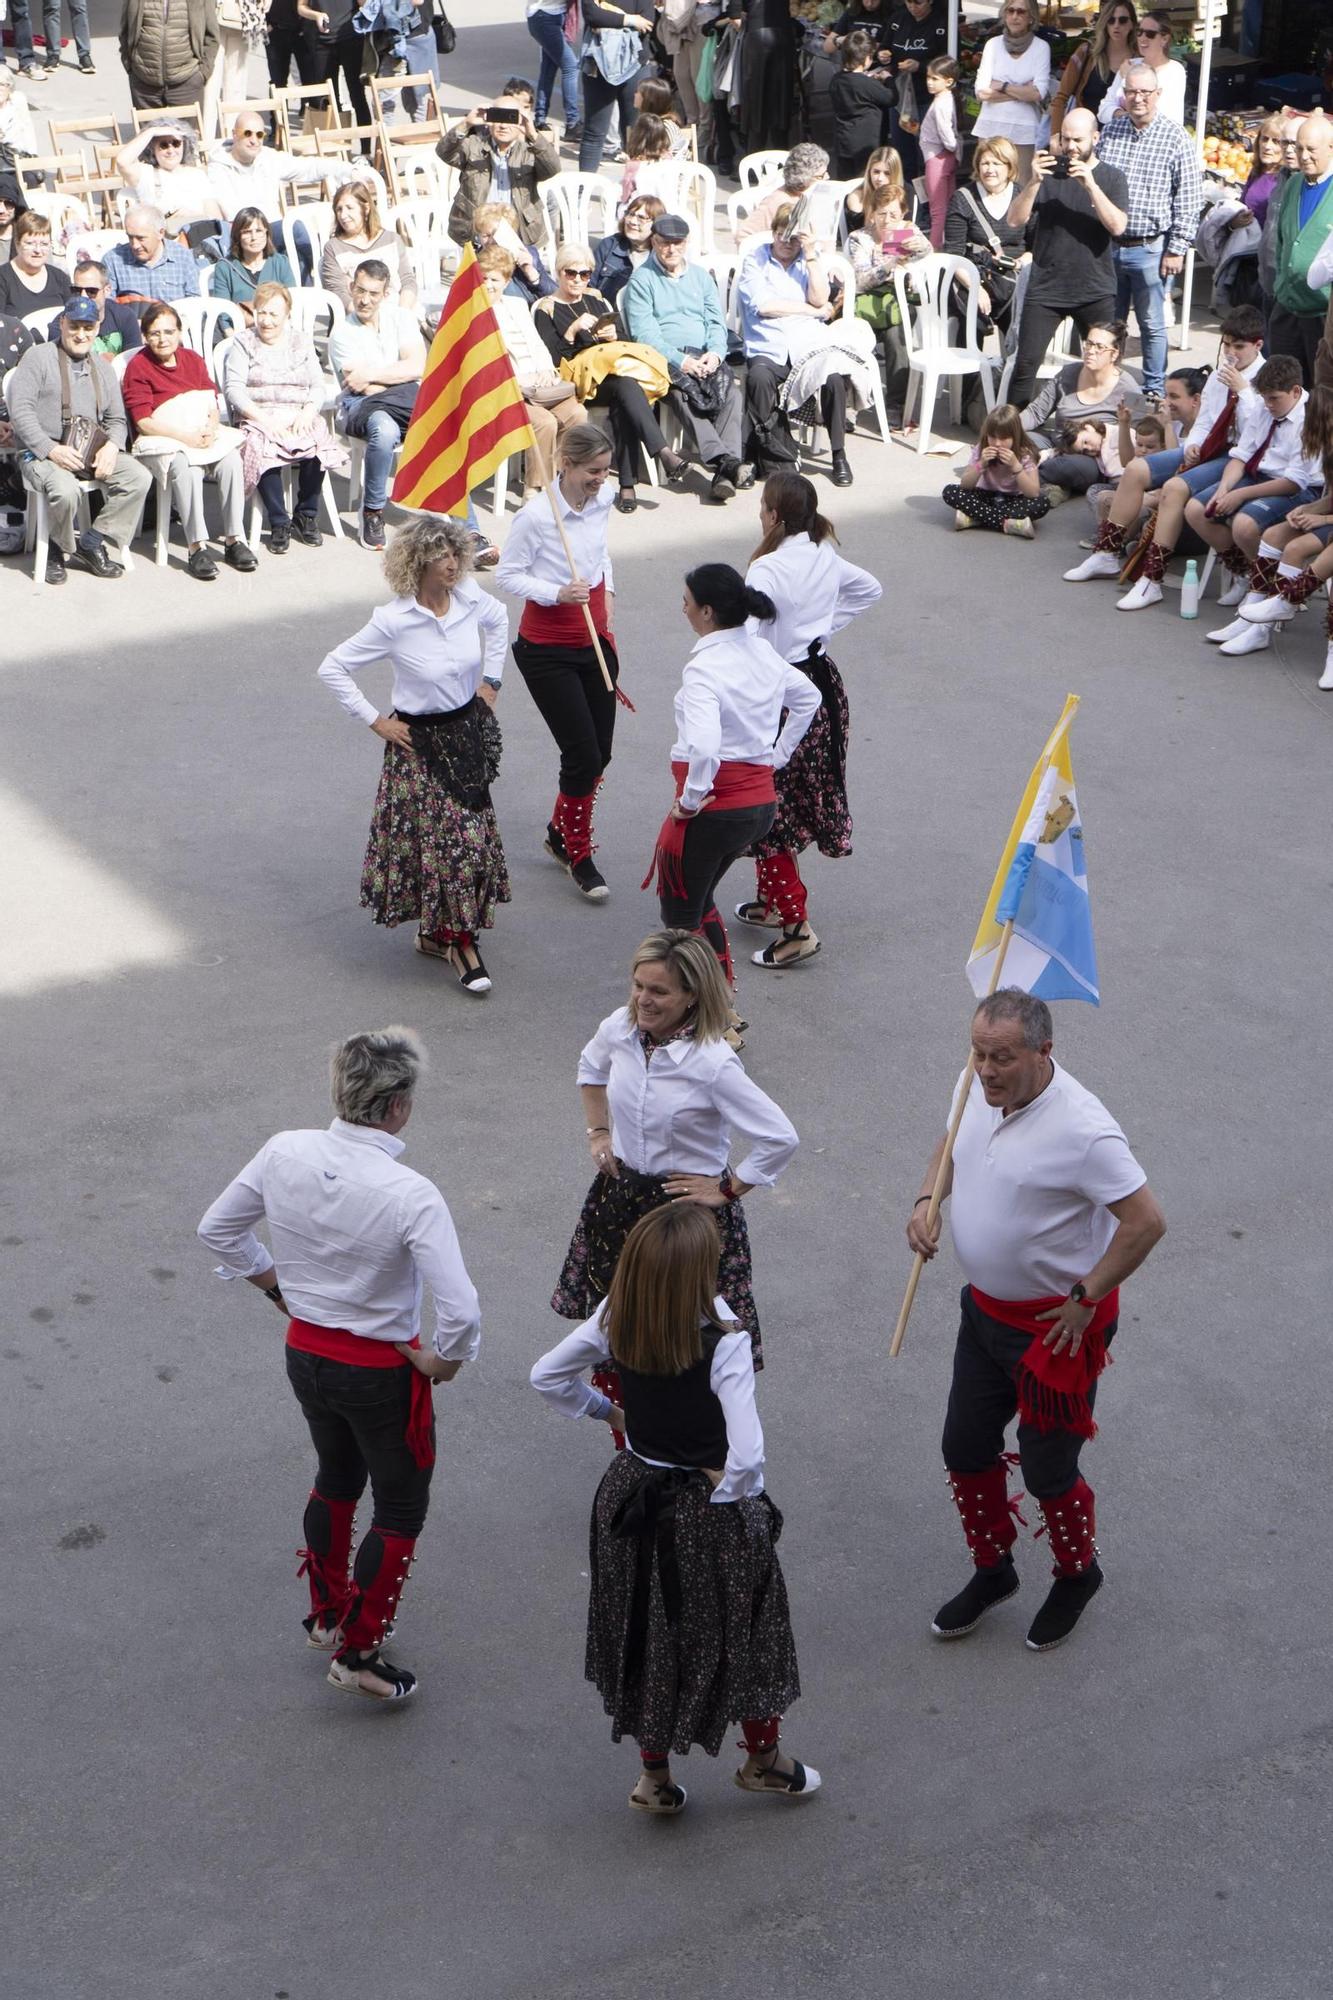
[{"left": 642, "top": 562, "right": 819, "bottom": 986}]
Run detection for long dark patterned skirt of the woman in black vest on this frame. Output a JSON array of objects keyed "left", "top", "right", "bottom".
[{"left": 584, "top": 1452, "right": 801, "bottom": 1756}]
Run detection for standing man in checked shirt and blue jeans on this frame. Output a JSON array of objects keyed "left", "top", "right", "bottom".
[{"left": 1097, "top": 62, "right": 1201, "bottom": 396}]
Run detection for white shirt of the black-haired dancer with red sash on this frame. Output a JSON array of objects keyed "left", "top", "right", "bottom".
[{"left": 671, "top": 626, "right": 819, "bottom": 812}]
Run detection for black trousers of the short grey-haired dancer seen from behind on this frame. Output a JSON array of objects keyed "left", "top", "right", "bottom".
[{"left": 286, "top": 1348, "right": 434, "bottom": 1536}]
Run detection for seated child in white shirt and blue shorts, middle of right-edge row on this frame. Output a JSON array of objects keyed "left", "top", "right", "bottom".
[{"left": 1117, "top": 354, "right": 1327, "bottom": 612}]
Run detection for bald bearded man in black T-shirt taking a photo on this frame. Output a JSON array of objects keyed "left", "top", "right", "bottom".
[{"left": 1009, "top": 110, "right": 1129, "bottom": 410}]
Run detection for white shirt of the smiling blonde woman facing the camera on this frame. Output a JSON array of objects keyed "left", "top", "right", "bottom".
[{"left": 578, "top": 1006, "right": 801, "bottom": 1188}]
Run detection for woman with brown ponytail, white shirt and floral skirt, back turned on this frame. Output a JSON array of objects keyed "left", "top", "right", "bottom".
[{"left": 737, "top": 472, "right": 883, "bottom": 972}]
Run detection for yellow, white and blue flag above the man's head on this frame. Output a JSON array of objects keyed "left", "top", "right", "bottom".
[{"left": 967, "top": 694, "right": 1101, "bottom": 1006}]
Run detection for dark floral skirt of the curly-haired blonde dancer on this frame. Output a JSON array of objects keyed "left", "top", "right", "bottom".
[{"left": 360, "top": 700, "right": 510, "bottom": 934}]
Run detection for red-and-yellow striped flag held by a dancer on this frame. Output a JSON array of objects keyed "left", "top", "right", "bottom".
[{"left": 392, "top": 244, "right": 536, "bottom": 514}]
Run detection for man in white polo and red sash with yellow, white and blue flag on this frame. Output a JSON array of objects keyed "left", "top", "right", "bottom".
[{"left": 899, "top": 700, "right": 1167, "bottom": 1652}]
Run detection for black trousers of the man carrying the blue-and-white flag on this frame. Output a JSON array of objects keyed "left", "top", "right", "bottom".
[{"left": 943, "top": 1284, "right": 1119, "bottom": 1500}]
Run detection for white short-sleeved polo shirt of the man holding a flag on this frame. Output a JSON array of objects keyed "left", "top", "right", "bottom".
[{"left": 949, "top": 1062, "right": 1147, "bottom": 1298}]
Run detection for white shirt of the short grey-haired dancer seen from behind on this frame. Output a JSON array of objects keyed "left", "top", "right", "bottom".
[{"left": 198, "top": 1118, "right": 480, "bottom": 1362}]
